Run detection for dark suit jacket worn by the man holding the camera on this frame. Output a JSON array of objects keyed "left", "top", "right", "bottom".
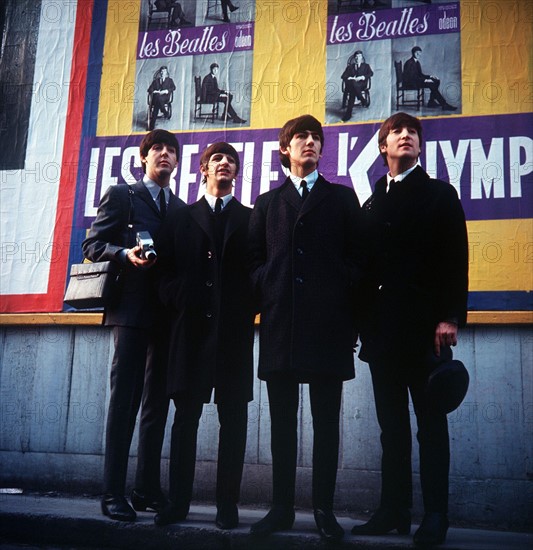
[{"left": 82, "top": 181, "right": 185, "bottom": 328}]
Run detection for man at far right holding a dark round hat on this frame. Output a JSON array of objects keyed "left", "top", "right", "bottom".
[{"left": 352, "top": 113, "right": 468, "bottom": 544}]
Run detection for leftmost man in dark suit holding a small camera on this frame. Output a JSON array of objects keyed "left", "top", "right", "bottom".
[{"left": 82, "top": 130, "right": 185, "bottom": 521}]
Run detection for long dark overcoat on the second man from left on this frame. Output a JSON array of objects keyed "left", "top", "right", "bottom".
[{"left": 157, "top": 198, "right": 255, "bottom": 403}]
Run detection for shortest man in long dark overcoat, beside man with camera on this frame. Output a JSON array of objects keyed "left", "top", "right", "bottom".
[{"left": 155, "top": 142, "right": 255, "bottom": 529}]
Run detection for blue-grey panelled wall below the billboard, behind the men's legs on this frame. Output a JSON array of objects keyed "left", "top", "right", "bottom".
[{"left": 0, "top": 326, "right": 533, "bottom": 529}]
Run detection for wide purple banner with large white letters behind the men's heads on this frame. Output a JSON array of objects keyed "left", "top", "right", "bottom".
[{"left": 76, "top": 113, "right": 533, "bottom": 226}]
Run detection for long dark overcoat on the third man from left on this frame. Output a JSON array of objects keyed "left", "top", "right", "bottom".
[{"left": 249, "top": 176, "right": 360, "bottom": 382}]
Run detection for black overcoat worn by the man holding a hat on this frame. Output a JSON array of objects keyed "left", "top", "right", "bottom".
[{"left": 359, "top": 166, "right": 468, "bottom": 361}]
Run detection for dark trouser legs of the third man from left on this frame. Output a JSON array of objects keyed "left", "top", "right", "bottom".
[{"left": 267, "top": 374, "right": 342, "bottom": 510}]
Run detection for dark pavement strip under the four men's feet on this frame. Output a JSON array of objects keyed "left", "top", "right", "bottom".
[{"left": 0, "top": 494, "right": 533, "bottom": 550}]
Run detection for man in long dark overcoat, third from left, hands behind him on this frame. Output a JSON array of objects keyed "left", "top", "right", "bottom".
[{"left": 249, "top": 115, "right": 360, "bottom": 540}]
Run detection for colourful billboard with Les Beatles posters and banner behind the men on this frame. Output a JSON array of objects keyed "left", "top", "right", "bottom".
[{"left": 0, "top": 0, "right": 533, "bottom": 312}]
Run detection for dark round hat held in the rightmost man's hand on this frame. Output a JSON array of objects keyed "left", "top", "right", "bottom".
[{"left": 426, "top": 348, "right": 470, "bottom": 414}]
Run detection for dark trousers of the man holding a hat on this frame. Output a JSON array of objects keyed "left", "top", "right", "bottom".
[{"left": 370, "top": 359, "right": 450, "bottom": 513}]
